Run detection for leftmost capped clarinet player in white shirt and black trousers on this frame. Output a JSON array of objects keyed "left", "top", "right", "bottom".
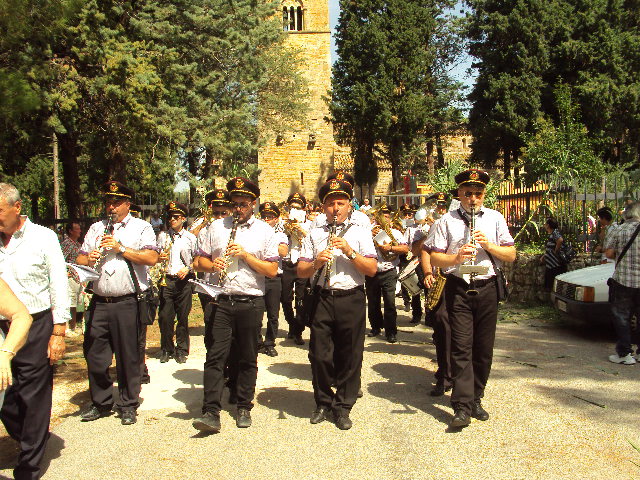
[{"left": 77, "top": 181, "right": 158, "bottom": 425}]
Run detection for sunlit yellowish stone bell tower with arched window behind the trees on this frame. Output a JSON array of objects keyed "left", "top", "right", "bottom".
[{"left": 258, "top": 0, "right": 336, "bottom": 202}]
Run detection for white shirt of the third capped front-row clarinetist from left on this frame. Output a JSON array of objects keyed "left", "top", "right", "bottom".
[{"left": 299, "top": 220, "right": 377, "bottom": 290}]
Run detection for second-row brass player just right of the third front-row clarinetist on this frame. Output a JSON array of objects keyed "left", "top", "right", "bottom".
[{"left": 365, "top": 204, "right": 409, "bottom": 343}]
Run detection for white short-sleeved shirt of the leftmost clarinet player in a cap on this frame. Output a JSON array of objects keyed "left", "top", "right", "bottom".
[{"left": 80, "top": 215, "right": 158, "bottom": 297}]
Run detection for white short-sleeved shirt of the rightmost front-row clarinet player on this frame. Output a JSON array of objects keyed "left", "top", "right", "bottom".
[{"left": 422, "top": 207, "right": 513, "bottom": 280}]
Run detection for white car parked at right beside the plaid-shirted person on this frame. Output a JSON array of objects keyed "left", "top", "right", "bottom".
[{"left": 551, "top": 263, "right": 615, "bottom": 325}]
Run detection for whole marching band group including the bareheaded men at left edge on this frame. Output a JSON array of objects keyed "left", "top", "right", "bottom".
[{"left": 0, "top": 169, "right": 515, "bottom": 479}]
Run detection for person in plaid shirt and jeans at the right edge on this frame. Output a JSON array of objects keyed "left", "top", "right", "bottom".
[{"left": 604, "top": 202, "right": 640, "bottom": 365}]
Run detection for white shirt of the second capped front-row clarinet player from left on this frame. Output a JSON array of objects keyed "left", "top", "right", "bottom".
[{"left": 198, "top": 216, "right": 280, "bottom": 296}]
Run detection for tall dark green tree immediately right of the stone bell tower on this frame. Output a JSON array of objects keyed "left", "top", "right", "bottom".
[{"left": 330, "top": 0, "right": 458, "bottom": 191}]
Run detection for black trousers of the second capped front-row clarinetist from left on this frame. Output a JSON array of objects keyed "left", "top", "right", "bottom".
[{"left": 202, "top": 297, "right": 264, "bottom": 414}]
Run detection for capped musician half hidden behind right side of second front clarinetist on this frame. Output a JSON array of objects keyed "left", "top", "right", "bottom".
[{"left": 258, "top": 202, "right": 289, "bottom": 357}]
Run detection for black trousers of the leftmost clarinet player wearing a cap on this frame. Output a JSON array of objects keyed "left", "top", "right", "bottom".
[{"left": 84, "top": 296, "right": 140, "bottom": 410}]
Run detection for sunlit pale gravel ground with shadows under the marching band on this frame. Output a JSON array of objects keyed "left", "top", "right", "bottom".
[{"left": 0, "top": 302, "right": 640, "bottom": 480}]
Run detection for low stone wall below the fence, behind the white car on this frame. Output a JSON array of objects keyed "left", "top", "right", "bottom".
[{"left": 504, "top": 253, "right": 600, "bottom": 303}]
